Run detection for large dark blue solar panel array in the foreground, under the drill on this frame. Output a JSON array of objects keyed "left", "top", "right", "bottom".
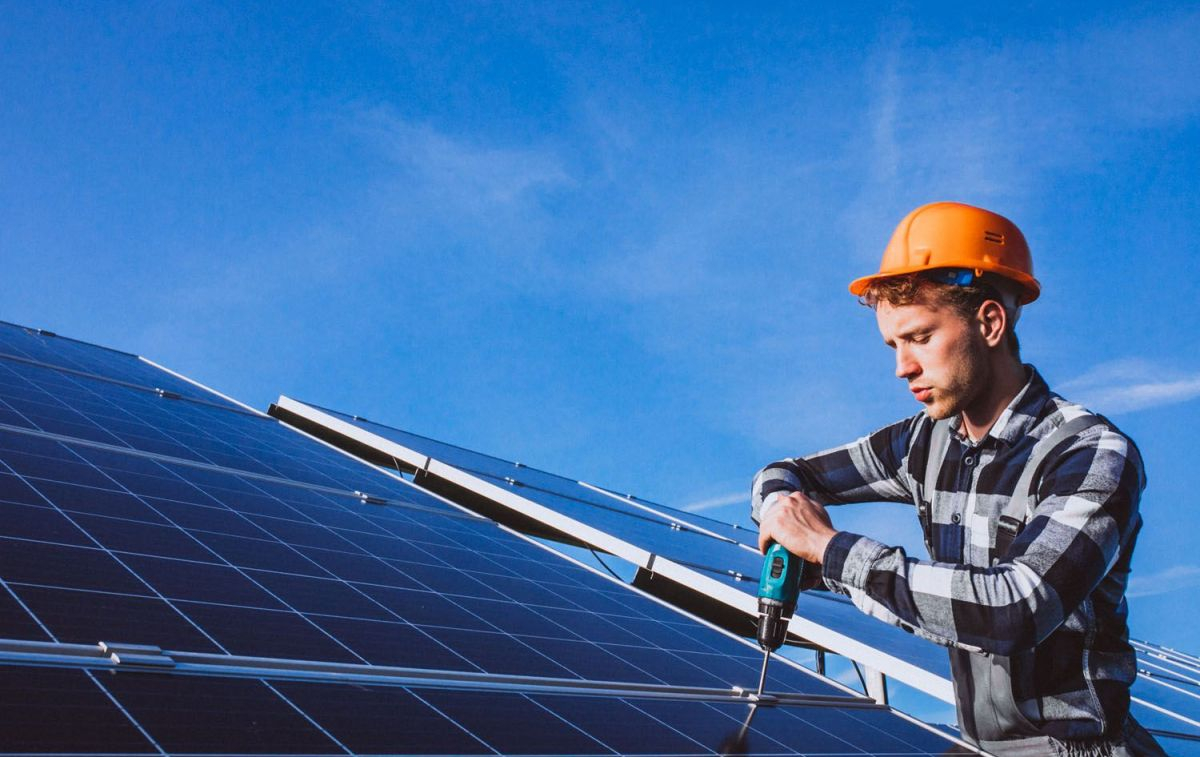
[{"left": 0, "top": 326, "right": 972, "bottom": 755}]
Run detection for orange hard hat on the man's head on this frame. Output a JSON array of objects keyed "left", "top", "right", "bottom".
[{"left": 850, "top": 203, "right": 1042, "bottom": 305}]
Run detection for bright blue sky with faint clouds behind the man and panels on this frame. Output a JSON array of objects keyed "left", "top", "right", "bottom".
[{"left": 0, "top": 2, "right": 1200, "bottom": 651}]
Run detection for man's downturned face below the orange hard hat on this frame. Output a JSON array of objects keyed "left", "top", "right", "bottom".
[{"left": 875, "top": 297, "right": 989, "bottom": 420}]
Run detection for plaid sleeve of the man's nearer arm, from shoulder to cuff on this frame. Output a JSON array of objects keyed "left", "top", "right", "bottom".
[{"left": 822, "top": 426, "right": 1145, "bottom": 655}]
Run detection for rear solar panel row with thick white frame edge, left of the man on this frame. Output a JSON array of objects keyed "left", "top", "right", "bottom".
[{"left": 270, "top": 397, "right": 954, "bottom": 703}]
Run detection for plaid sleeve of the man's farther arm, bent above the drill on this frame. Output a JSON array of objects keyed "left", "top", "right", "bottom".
[{"left": 750, "top": 414, "right": 924, "bottom": 523}]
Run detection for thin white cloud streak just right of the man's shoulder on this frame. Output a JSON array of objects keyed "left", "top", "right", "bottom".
[{"left": 1060, "top": 358, "right": 1200, "bottom": 413}]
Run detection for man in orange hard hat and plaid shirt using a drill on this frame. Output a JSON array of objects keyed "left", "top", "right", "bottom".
[{"left": 752, "top": 203, "right": 1163, "bottom": 756}]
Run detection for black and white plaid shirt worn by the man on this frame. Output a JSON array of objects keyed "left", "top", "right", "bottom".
[{"left": 752, "top": 366, "right": 1146, "bottom": 740}]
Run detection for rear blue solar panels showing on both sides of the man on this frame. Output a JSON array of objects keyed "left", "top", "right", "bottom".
[{"left": 272, "top": 397, "right": 1200, "bottom": 757}]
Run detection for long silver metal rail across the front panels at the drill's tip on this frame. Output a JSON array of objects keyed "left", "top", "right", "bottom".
[{"left": 0, "top": 639, "right": 888, "bottom": 709}]
